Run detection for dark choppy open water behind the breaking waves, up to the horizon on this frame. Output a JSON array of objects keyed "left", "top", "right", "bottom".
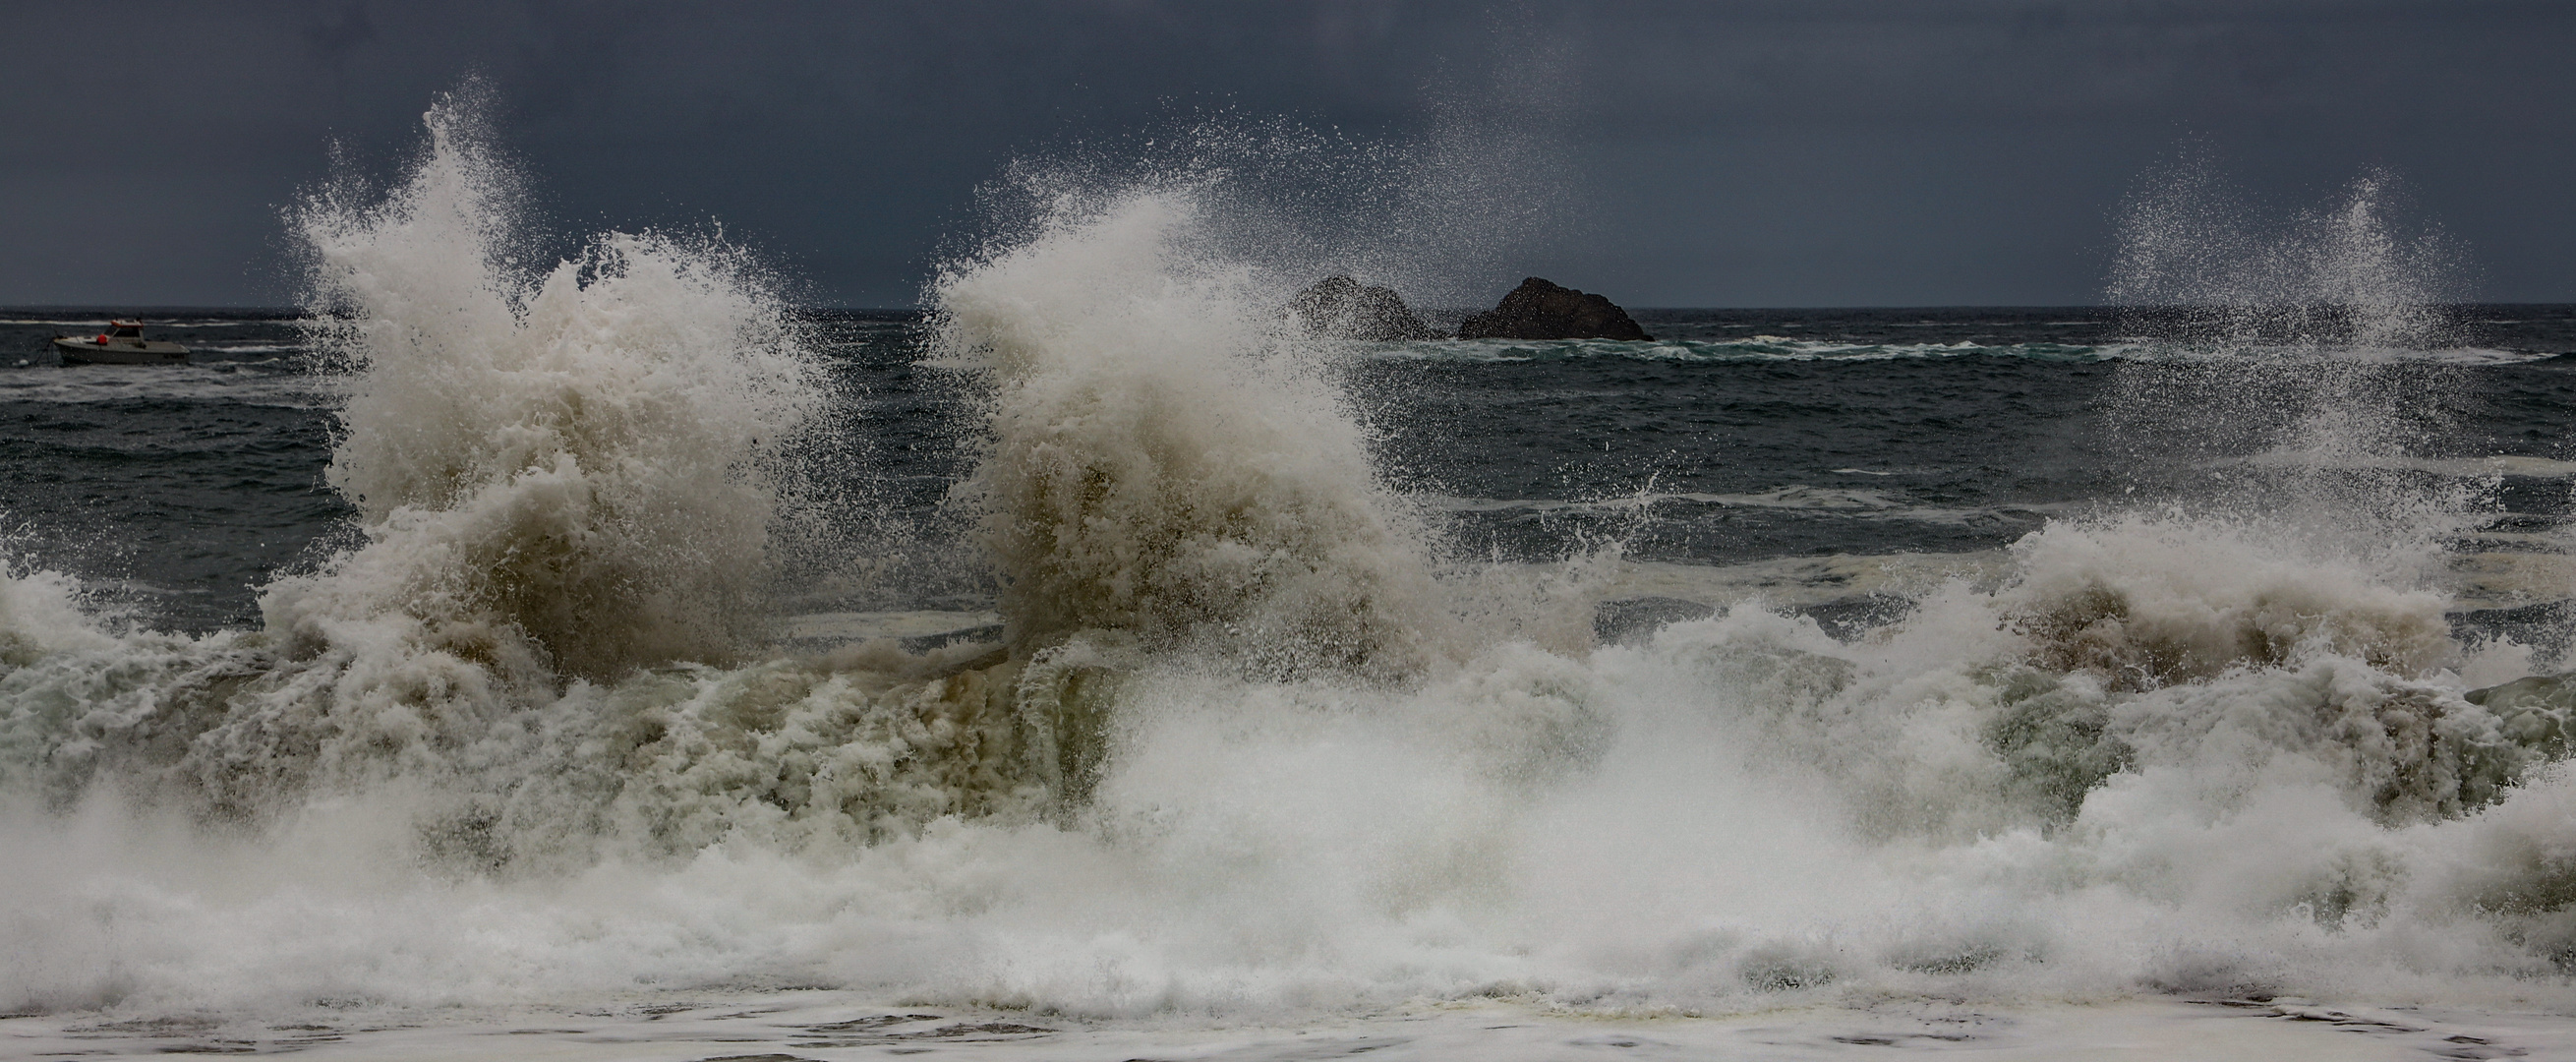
[{"left": 15, "top": 307, "right": 2576, "bottom": 634}]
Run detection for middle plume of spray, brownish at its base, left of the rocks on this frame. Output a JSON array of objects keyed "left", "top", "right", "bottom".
[{"left": 935, "top": 188, "right": 1437, "bottom": 673}]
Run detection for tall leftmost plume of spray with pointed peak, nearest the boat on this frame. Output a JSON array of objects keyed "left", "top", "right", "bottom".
[{"left": 263, "top": 90, "right": 819, "bottom": 676}]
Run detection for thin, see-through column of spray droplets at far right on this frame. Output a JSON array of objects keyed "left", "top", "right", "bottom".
[{"left": 2105, "top": 152, "right": 2481, "bottom": 590}]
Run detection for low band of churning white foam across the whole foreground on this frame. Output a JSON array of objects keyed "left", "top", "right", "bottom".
[{"left": 15, "top": 526, "right": 2571, "bottom": 1018}]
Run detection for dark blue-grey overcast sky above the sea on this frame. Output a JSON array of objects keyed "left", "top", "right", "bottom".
[{"left": 0, "top": 0, "right": 2576, "bottom": 307}]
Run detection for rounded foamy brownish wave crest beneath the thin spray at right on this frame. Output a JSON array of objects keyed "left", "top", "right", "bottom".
[{"left": 1989, "top": 515, "right": 2560, "bottom": 822}]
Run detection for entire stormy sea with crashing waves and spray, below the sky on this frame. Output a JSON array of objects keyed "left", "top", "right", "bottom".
[{"left": 0, "top": 108, "right": 2576, "bottom": 1062}]
